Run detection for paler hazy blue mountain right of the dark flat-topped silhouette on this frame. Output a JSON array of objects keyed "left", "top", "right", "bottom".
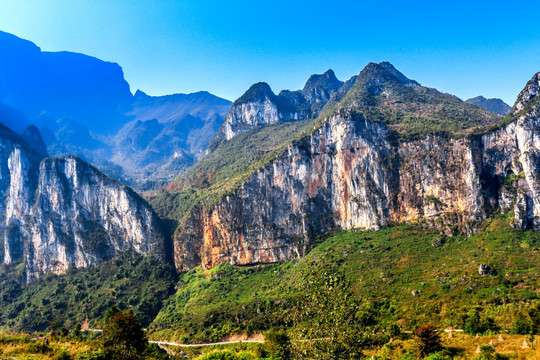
[{"left": 113, "top": 90, "right": 231, "bottom": 186}]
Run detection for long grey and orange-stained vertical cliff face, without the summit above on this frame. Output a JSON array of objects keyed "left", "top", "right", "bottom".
[{"left": 175, "top": 72, "right": 540, "bottom": 269}]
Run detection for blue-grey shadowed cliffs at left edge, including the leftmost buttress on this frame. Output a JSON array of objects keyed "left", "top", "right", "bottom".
[{"left": 0, "top": 125, "right": 166, "bottom": 280}]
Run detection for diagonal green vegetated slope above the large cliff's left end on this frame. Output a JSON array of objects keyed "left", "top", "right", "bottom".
[{"left": 149, "top": 120, "right": 313, "bottom": 222}]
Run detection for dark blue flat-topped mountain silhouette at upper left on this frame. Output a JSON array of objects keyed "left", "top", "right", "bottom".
[{"left": 0, "top": 32, "right": 132, "bottom": 133}]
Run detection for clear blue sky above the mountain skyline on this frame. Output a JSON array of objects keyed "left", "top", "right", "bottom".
[{"left": 0, "top": 0, "right": 540, "bottom": 104}]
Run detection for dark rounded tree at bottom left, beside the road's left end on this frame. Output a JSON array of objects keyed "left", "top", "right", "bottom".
[{"left": 102, "top": 307, "right": 148, "bottom": 360}]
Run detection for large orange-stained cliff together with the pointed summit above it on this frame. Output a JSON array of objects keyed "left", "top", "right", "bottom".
[{"left": 163, "top": 64, "right": 540, "bottom": 270}]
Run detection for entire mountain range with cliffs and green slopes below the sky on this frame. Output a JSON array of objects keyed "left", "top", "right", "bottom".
[{"left": 0, "top": 28, "right": 540, "bottom": 346}]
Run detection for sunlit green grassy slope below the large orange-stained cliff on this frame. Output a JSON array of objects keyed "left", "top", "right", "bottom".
[{"left": 151, "top": 216, "right": 540, "bottom": 341}]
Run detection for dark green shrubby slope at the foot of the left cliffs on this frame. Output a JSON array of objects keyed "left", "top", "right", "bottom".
[{"left": 0, "top": 254, "right": 176, "bottom": 331}]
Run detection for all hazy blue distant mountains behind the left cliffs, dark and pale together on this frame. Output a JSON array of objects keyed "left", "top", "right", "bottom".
[{"left": 0, "top": 32, "right": 230, "bottom": 190}]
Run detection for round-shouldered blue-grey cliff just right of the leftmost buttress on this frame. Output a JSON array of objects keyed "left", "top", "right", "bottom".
[{"left": 26, "top": 157, "right": 165, "bottom": 278}]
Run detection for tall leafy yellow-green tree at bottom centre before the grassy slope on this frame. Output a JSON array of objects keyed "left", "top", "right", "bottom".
[{"left": 291, "top": 270, "right": 378, "bottom": 359}]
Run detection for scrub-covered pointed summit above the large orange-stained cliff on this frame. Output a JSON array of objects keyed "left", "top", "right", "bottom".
[{"left": 330, "top": 64, "right": 501, "bottom": 141}]
